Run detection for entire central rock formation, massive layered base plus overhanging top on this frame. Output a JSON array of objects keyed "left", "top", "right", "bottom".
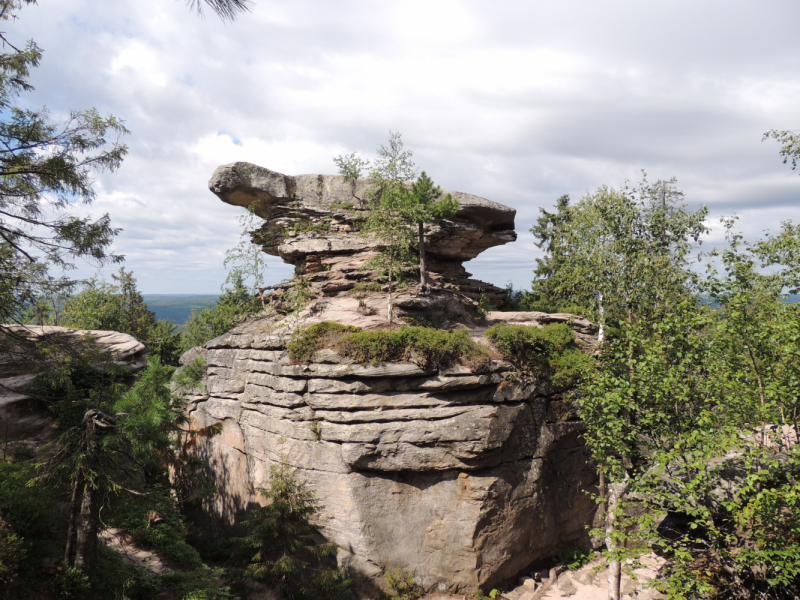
[{"left": 188, "top": 163, "right": 596, "bottom": 590}]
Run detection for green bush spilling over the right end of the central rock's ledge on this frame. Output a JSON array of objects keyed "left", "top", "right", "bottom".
[{"left": 486, "top": 323, "right": 593, "bottom": 388}]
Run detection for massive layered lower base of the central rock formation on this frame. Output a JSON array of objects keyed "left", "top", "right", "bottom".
[{"left": 185, "top": 307, "right": 594, "bottom": 590}]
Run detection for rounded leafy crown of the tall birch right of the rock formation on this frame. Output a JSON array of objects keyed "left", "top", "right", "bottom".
[{"left": 531, "top": 177, "right": 708, "bottom": 338}]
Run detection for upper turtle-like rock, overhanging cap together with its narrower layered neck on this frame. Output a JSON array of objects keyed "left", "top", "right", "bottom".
[{"left": 208, "top": 162, "right": 517, "bottom": 302}]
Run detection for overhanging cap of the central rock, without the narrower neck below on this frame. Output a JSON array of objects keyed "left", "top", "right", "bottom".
[{"left": 208, "top": 162, "right": 516, "bottom": 264}]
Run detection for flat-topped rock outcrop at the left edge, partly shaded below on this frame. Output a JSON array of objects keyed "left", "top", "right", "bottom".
[{"left": 0, "top": 325, "right": 147, "bottom": 440}]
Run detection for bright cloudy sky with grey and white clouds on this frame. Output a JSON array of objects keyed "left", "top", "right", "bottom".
[{"left": 12, "top": 0, "right": 800, "bottom": 294}]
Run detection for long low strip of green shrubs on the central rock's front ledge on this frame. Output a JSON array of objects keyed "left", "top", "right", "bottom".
[{"left": 289, "top": 321, "right": 488, "bottom": 369}]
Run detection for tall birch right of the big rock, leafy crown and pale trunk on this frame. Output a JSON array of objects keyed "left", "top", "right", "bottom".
[{"left": 532, "top": 179, "right": 706, "bottom": 600}]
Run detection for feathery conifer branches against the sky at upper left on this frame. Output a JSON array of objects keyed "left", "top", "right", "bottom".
[{"left": 0, "top": 0, "right": 128, "bottom": 323}]
